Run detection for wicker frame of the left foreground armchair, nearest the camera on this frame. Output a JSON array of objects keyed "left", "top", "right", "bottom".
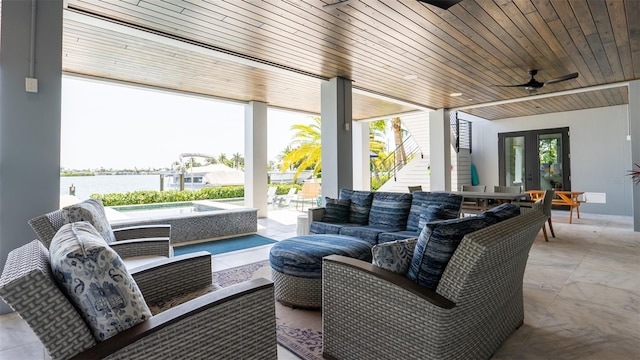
[{"left": 0, "top": 240, "right": 277, "bottom": 359}]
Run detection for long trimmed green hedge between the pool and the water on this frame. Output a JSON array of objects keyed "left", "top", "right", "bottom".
[{"left": 91, "top": 184, "right": 301, "bottom": 206}]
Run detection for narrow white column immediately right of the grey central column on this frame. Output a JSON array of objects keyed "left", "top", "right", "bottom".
[{"left": 353, "top": 121, "right": 371, "bottom": 190}]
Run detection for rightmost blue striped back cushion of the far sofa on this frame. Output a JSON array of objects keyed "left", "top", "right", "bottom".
[{"left": 406, "top": 191, "right": 462, "bottom": 233}]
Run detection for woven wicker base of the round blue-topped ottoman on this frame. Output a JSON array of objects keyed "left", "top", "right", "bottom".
[{"left": 271, "top": 269, "right": 322, "bottom": 309}]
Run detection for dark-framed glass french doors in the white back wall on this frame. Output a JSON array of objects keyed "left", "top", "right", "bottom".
[{"left": 498, "top": 128, "right": 571, "bottom": 191}]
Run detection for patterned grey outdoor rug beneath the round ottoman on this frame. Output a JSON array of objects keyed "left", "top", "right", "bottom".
[{"left": 213, "top": 260, "right": 322, "bottom": 360}]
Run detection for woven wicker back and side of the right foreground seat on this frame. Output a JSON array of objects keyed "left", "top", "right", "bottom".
[{"left": 322, "top": 212, "right": 546, "bottom": 359}]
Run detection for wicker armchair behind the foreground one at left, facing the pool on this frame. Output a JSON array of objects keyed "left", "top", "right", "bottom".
[{"left": 28, "top": 201, "right": 172, "bottom": 267}]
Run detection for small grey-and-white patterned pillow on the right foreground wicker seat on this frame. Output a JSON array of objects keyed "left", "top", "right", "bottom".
[{"left": 371, "top": 238, "right": 418, "bottom": 275}]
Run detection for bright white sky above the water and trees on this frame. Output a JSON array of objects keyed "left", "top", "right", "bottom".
[{"left": 60, "top": 76, "right": 311, "bottom": 169}]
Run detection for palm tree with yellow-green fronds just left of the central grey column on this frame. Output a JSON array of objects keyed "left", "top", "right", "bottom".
[{"left": 280, "top": 116, "right": 322, "bottom": 182}]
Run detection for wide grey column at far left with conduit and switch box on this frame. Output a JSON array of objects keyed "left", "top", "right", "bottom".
[{"left": 0, "top": 0, "right": 62, "bottom": 313}]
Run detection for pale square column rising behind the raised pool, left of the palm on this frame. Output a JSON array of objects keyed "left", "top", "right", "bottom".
[{"left": 244, "top": 101, "right": 268, "bottom": 218}]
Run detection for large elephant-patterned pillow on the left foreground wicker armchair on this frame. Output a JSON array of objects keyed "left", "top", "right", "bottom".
[{"left": 49, "top": 222, "right": 151, "bottom": 341}]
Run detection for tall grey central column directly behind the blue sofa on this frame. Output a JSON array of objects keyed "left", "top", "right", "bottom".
[{"left": 321, "top": 78, "right": 353, "bottom": 197}]
